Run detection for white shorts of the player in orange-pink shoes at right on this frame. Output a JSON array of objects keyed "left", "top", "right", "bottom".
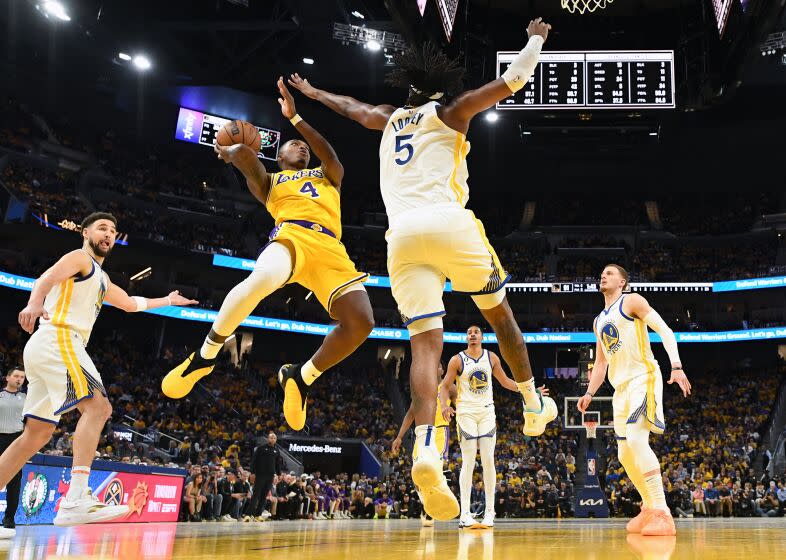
[{"left": 611, "top": 369, "right": 666, "bottom": 439}]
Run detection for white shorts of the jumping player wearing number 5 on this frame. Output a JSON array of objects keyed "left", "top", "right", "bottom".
[{"left": 386, "top": 204, "right": 510, "bottom": 326}]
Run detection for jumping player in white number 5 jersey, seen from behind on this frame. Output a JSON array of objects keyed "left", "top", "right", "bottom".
[{"left": 289, "top": 18, "right": 557, "bottom": 519}]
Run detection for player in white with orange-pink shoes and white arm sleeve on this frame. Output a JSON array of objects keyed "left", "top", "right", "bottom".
[{"left": 577, "top": 264, "right": 691, "bottom": 536}]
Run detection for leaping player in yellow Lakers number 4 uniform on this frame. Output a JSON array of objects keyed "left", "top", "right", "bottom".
[{"left": 161, "top": 79, "right": 374, "bottom": 430}]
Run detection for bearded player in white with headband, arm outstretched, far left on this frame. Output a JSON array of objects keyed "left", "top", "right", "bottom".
[{"left": 6, "top": 212, "right": 197, "bottom": 526}]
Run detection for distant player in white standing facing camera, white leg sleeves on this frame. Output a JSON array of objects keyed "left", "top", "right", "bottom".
[{"left": 439, "top": 325, "right": 548, "bottom": 527}]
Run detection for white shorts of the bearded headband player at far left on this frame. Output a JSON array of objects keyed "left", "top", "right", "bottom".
[{"left": 23, "top": 325, "right": 106, "bottom": 424}]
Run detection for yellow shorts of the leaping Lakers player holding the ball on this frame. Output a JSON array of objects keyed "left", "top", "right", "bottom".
[{"left": 270, "top": 222, "right": 368, "bottom": 317}]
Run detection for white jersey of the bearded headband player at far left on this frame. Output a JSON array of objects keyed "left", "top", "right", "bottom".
[{"left": 41, "top": 252, "right": 109, "bottom": 345}]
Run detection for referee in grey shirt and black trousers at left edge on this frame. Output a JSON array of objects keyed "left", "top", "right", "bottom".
[{"left": 0, "top": 366, "right": 27, "bottom": 529}]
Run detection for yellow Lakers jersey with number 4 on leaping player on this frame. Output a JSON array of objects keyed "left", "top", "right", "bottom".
[{"left": 265, "top": 167, "right": 341, "bottom": 239}]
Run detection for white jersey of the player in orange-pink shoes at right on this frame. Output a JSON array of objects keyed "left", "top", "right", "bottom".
[{"left": 593, "top": 295, "right": 660, "bottom": 389}]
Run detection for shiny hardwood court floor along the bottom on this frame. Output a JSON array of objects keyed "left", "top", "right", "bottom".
[{"left": 0, "top": 518, "right": 786, "bottom": 560}]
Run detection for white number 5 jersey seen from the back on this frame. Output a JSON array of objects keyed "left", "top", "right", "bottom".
[{"left": 379, "top": 101, "right": 469, "bottom": 218}]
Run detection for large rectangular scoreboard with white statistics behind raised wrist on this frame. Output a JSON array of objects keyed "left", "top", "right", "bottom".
[{"left": 497, "top": 51, "right": 676, "bottom": 109}]
